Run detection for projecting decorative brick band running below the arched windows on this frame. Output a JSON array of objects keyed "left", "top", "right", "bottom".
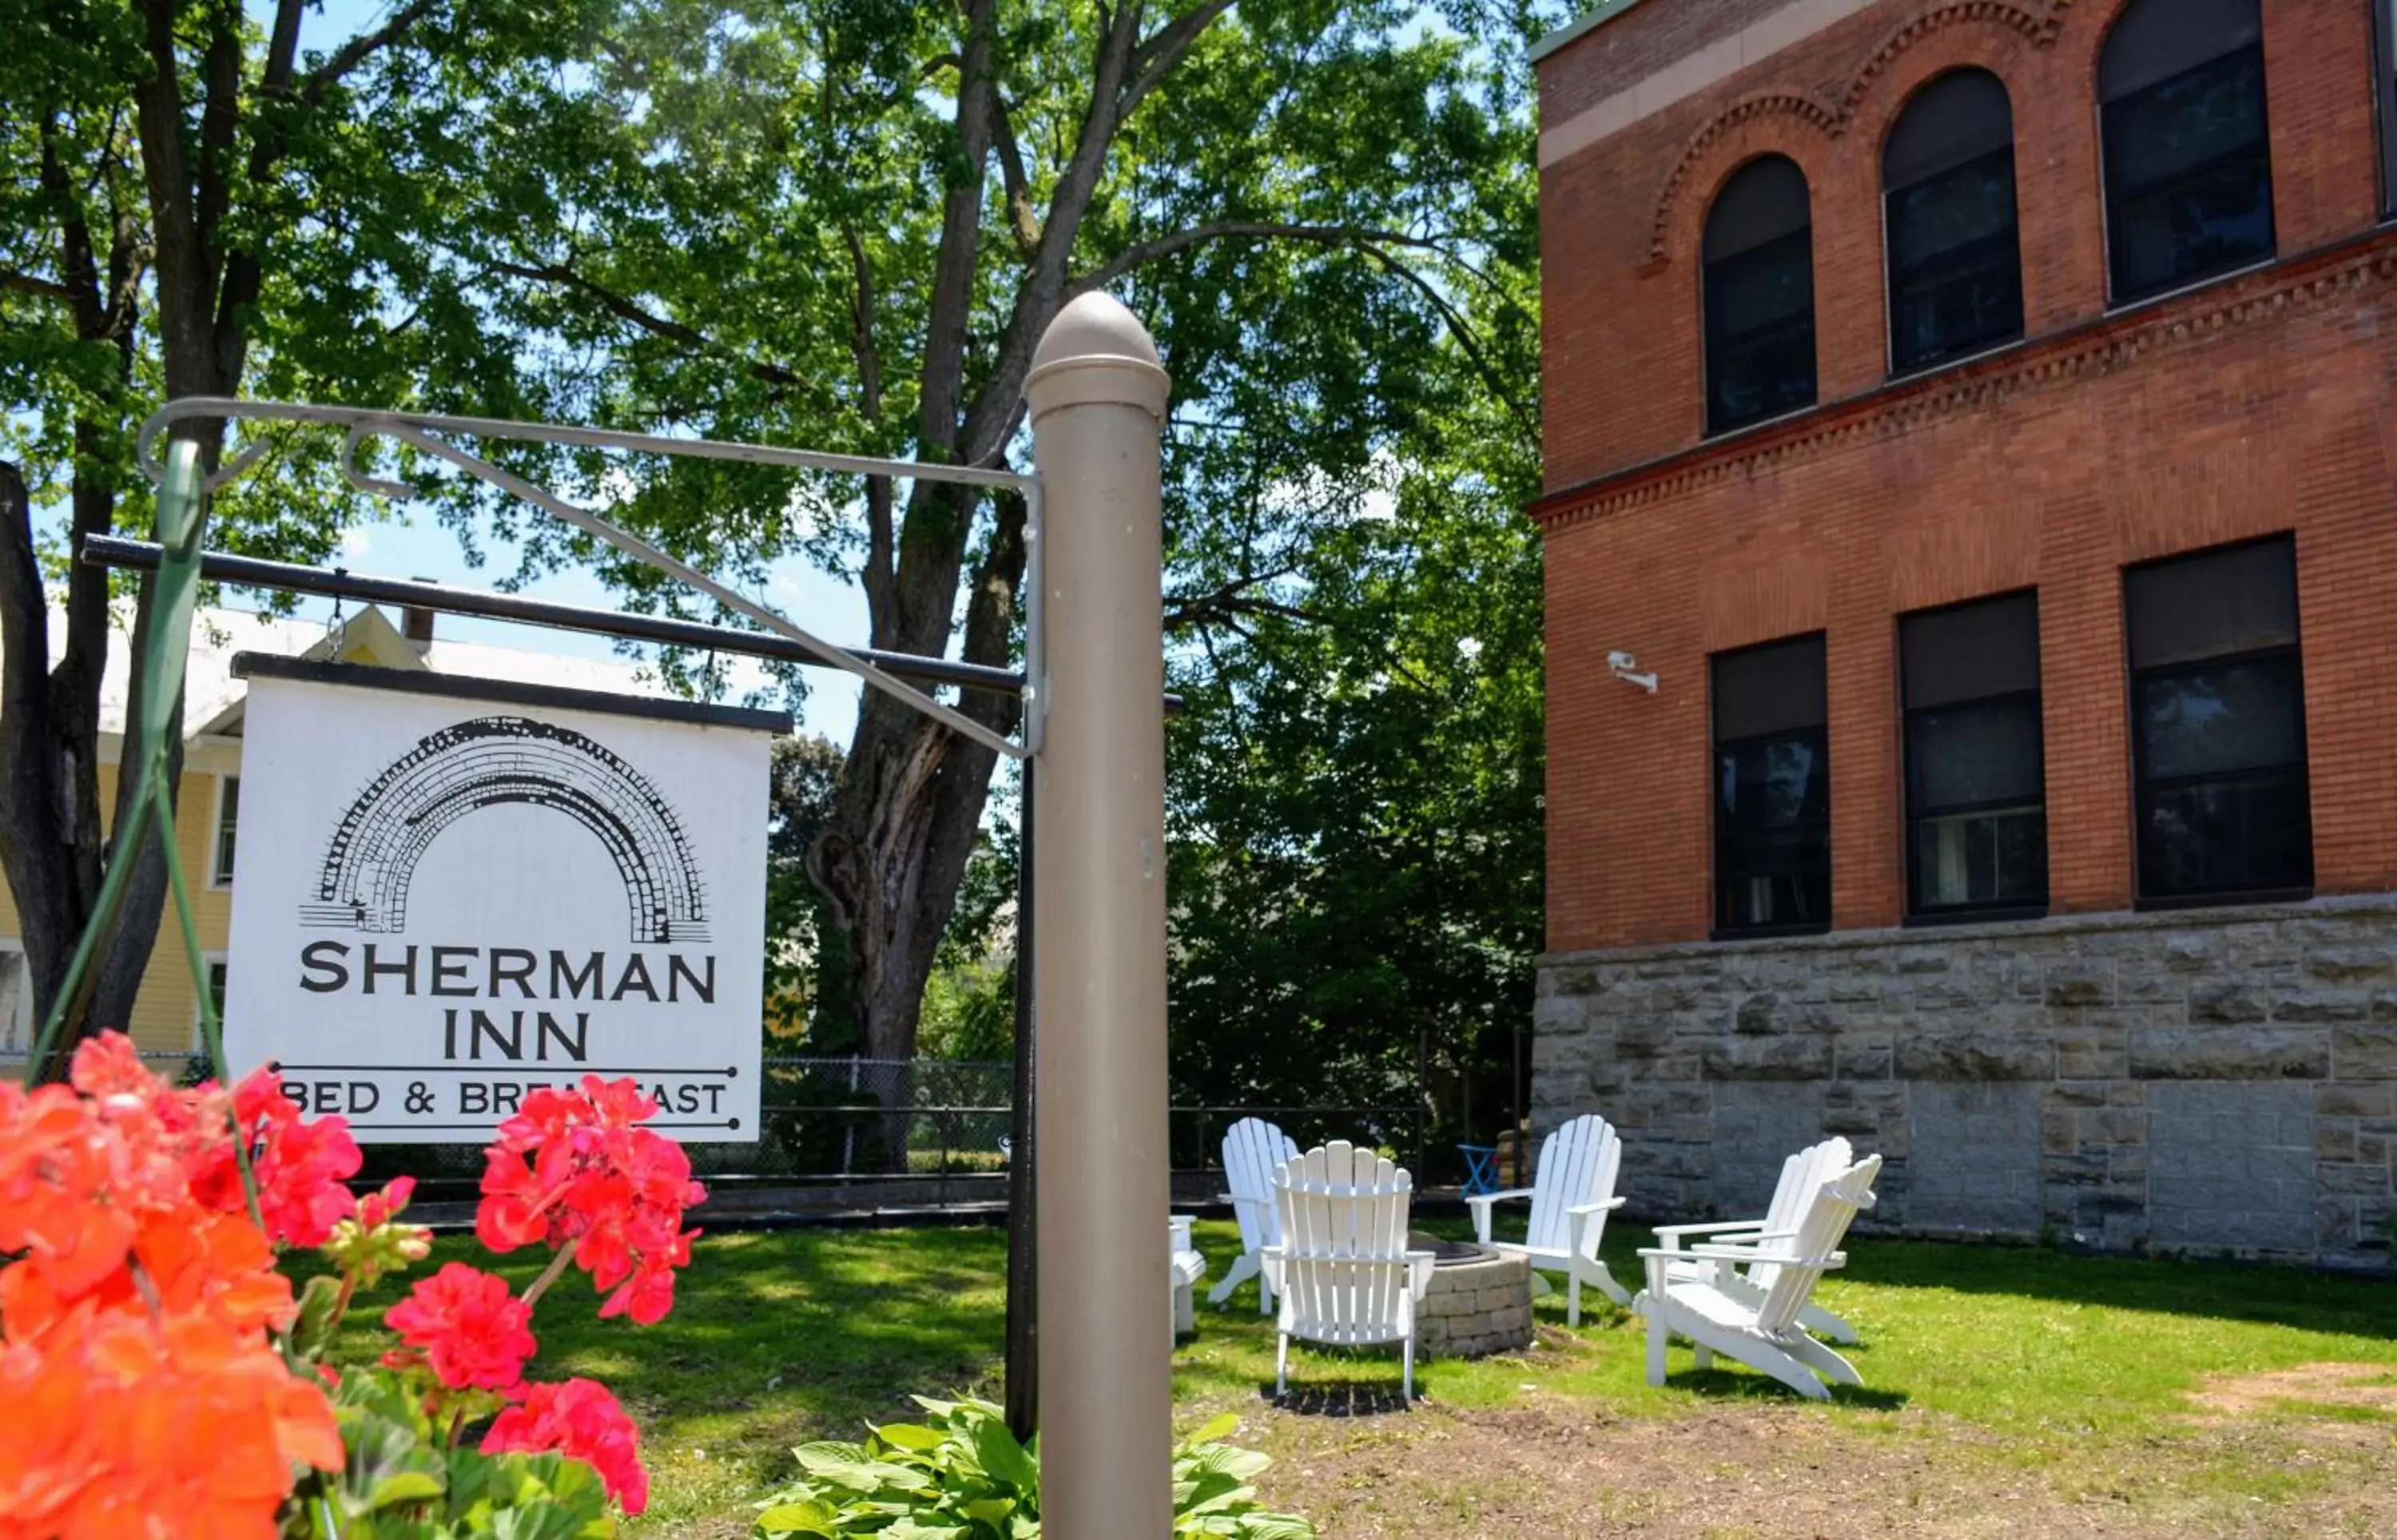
[{"left": 1524, "top": 228, "right": 2397, "bottom": 537}]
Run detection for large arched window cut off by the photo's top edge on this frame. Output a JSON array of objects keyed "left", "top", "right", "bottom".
[{"left": 2097, "top": 0, "right": 2272, "bottom": 304}]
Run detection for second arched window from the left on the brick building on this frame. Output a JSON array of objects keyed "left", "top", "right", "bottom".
[{"left": 1882, "top": 69, "right": 2023, "bottom": 374}]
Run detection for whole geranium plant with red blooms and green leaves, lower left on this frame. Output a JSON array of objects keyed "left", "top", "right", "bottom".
[{"left": 0, "top": 1032, "right": 705, "bottom": 1540}]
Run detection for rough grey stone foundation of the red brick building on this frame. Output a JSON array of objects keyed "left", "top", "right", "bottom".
[{"left": 1532, "top": 898, "right": 2397, "bottom": 1269}]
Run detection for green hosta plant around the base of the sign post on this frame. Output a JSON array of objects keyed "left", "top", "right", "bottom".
[{"left": 755, "top": 1396, "right": 1316, "bottom": 1540}]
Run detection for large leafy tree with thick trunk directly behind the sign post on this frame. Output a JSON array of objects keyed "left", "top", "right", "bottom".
[{"left": 343, "top": 0, "right": 1532, "bottom": 1082}]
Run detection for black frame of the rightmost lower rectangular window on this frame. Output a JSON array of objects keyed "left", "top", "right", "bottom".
[{"left": 2124, "top": 534, "right": 2313, "bottom": 910}]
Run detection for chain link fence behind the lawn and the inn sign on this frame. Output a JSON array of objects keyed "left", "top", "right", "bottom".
[{"left": 0, "top": 1054, "right": 1419, "bottom": 1205}]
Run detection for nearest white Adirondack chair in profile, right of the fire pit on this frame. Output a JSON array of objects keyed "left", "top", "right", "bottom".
[{"left": 1632, "top": 1154, "right": 1882, "bottom": 1401}]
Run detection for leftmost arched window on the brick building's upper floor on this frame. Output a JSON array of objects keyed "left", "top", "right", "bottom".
[{"left": 1702, "top": 156, "right": 1815, "bottom": 434}]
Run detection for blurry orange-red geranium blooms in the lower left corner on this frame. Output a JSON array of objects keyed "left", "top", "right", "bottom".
[{"left": 0, "top": 1034, "right": 343, "bottom": 1540}]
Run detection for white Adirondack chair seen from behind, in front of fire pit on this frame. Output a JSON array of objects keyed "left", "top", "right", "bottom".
[{"left": 1263, "top": 1140, "right": 1431, "bottom": 1401}]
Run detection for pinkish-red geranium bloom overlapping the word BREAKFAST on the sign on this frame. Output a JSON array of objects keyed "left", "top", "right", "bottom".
[{"left": 475, "top": 1075, "right": 707, "bottom": 1324}]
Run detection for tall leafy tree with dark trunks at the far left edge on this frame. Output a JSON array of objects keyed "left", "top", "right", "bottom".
[{"left": 0, "top": 0, "right": 453, "bottom": 1073}]
